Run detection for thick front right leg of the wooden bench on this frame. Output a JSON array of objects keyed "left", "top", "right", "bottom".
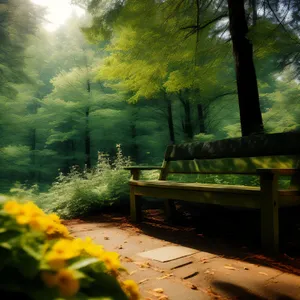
[{"left": 261, "top": 174, "right": 279, "bottom": 254}]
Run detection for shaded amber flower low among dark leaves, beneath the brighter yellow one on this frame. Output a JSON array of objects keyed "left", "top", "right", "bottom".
[{"left": 41, "top": 269, "right": 80, "bottom": 297}]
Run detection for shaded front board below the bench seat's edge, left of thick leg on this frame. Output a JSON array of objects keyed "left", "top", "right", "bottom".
[{"left": 134, "top": 186, "right": 260, "bottom": 208}]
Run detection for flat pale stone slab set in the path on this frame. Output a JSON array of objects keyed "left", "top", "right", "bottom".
[{"left": 138, "top": 246, "right": 198, "bottom": 262}]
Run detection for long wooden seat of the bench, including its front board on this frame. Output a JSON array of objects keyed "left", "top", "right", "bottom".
[{"left": 130, "top": 180, "right": 300, "bottom": 208}]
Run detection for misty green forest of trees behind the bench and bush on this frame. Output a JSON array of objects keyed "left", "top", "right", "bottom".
[{"left": 0, "top": 0, "right": 300, "bottom": 198}]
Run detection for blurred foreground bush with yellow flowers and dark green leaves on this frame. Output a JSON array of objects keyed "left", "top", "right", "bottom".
[{"left": 0, "top": 199, "right": 139, "bottom": 300}]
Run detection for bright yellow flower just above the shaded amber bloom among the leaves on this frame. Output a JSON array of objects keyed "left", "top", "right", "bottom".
[{"left": 46, "top": 239, "right": 80, "bottom": 269}]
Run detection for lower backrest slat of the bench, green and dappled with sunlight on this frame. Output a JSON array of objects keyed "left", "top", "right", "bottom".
[{"left": 168, "top": 156, "right": 298, "bottom": 175}]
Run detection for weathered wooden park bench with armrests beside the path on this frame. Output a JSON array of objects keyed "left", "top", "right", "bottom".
[{"left": 126, "top": 132, "right": 300, "bottom": 252}]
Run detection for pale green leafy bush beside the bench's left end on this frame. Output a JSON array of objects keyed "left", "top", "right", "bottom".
[{"left": 11, "top": 145, "right": 131, "bottom": 219}]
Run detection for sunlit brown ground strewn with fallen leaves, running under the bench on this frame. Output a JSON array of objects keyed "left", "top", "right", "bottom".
[{"left": 66, "top": 205, "right": 300, "bottom": 300}]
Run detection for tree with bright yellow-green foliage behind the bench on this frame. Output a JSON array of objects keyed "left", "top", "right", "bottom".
[{"left": 80, "top": 0, "right": 234, "bottom": 143}]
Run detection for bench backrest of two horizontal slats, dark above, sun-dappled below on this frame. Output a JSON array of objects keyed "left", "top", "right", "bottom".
[{"left": 160, "top": 132, "right": 300, "bottom": 186}]
